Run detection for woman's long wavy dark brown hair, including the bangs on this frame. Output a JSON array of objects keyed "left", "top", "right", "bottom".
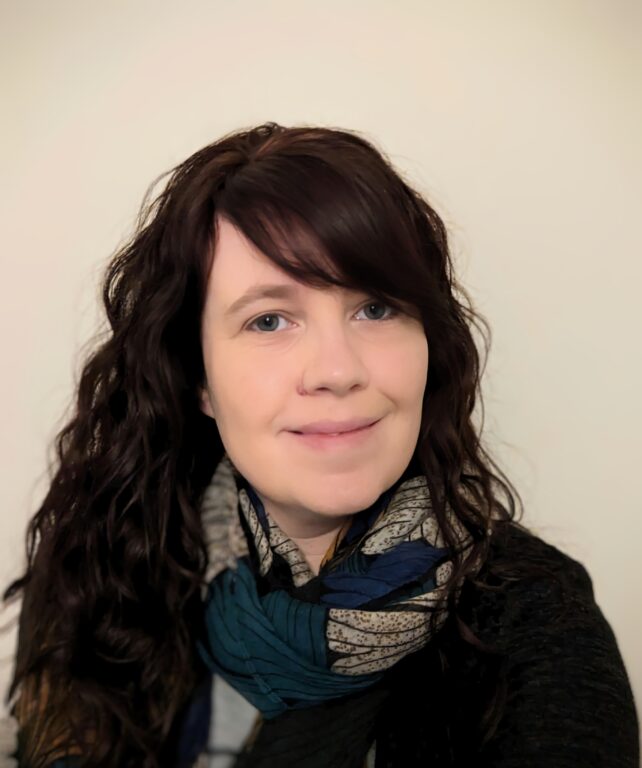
[{"left": 4, "top": 123, "right": 521, "bottom": 768}]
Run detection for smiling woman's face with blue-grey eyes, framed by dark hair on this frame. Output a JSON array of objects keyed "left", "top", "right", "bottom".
[{"left": 202, "top": 219, "right": 428, "bottom": 536}]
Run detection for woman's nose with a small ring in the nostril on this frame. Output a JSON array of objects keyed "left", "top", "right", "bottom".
[{"left": 298, "top": 323, "right": 369, "bottom": 395}]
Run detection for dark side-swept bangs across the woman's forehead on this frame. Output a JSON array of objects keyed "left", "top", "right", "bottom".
[{"left": 216, "top": 135, "right": 443, "bottom": 318}]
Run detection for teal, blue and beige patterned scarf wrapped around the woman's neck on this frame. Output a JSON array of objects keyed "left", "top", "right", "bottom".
[{"left": 198, "top": 456, "right": 470, "bottom": 719}]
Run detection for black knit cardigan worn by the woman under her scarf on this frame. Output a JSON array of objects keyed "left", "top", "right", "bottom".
[{"left": 37, "top": 523, "right": 639, "bottom": 768}]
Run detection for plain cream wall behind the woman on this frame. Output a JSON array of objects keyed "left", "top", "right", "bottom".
[{"left": 0, "top": 0, "right": 642, "bottom": 736}]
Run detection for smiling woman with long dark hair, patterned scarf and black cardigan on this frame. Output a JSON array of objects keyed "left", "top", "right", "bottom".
[{"left": 5, "top": 124, "right": 638, "bottom": 768}]
